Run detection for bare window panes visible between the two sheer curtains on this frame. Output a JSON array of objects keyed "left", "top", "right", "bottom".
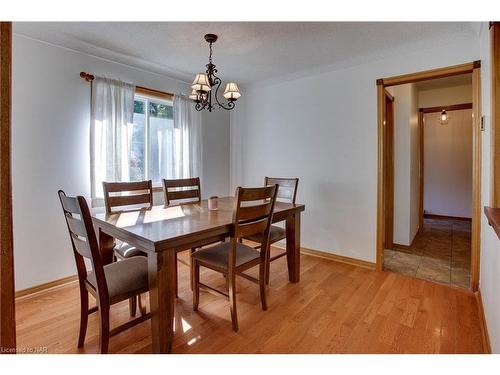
[{"left": 128, "top": 95, "right": 175, "bottom": 185}]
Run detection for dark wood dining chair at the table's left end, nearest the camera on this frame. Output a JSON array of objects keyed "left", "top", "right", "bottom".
[{"left": 58, "top": 190, "right": 150, "bottom": 353}]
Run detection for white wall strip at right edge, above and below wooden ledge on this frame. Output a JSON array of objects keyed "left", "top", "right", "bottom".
[{"left": 479, "top": 22, "right": 500, "bottom": 353}]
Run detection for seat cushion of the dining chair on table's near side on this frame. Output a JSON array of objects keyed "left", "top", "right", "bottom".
[{"left": 192, "top": 242, "right": 260, "bottom": 270}]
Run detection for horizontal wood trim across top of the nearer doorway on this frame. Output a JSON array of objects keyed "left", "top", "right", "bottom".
[{"left": 377, "top": 61, "right": 481, "bottom": 87}]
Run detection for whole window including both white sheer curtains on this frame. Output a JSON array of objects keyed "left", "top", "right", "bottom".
[{"left": 90, "top": 77, "right": 202, "bottom": 207}]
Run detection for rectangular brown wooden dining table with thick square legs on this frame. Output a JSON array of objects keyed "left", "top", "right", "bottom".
[{"left": 93, "top": 197, "right": 305, "bottom": 353}]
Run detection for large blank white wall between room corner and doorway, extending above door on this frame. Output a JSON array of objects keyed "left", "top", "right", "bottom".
[{"left": 231, "top": 38, "right": 479, "bottom": 262}]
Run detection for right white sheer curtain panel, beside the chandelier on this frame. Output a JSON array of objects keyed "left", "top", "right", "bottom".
[{"left": 173, "top": 95, "right": 203, "bottom": 178}]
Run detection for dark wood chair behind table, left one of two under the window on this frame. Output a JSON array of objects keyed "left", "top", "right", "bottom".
[{"left": 102, "top": 180, "right": 153, "bottom": 316}]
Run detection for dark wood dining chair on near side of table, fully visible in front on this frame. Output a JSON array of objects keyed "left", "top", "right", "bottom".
[{"left": 191, "top": 185, "right": 278, "bottom": 332}]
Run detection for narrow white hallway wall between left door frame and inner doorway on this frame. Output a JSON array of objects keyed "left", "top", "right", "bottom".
[{"left": 390, "top": 84, "right": 419, "bottom": 246}]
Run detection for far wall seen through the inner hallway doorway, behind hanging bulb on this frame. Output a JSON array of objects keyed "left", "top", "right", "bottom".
[{"left": 424, "top": 108, "right": 472, "bottom": 218}]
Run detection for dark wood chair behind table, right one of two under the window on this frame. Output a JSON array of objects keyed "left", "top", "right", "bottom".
[{"left": 163, "top": 177, "right": 201, "bottom": 296}]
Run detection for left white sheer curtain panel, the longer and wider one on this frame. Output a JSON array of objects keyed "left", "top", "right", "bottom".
[{"left": 90, "top": 77, "right": 135, "bottom": 205}]
